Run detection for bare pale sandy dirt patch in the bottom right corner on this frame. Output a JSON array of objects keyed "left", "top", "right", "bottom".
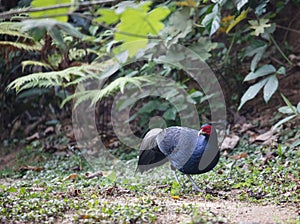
[{"left": 158, "top": 198, "right": 298, "bottom": 224}]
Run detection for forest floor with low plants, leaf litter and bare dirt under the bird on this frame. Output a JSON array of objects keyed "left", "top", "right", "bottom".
[{"left": 0, "top": 72, "right": 300, "bottom": 224}]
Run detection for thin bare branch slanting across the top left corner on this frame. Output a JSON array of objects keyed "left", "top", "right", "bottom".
[{"left": 0, "top": 0, "right": 116, "bottom": 19}]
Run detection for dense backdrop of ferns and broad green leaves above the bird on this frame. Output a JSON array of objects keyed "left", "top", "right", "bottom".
[{"left": 0, "top": 0, "right": 300, "bottom": 140}]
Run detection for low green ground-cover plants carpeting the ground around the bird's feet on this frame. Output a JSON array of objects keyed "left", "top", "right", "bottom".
[{"left": 0, "top": 135, "right": 300, "bottom": 223}]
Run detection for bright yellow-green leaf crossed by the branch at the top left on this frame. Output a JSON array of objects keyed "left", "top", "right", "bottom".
[{"left": 29, "top": 0, "right": 71, "bottom": 22}]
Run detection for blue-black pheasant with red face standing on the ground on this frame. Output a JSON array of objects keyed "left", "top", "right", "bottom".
[{"left": 138, "top": 124, "right": 220, "bottom": 190}]
